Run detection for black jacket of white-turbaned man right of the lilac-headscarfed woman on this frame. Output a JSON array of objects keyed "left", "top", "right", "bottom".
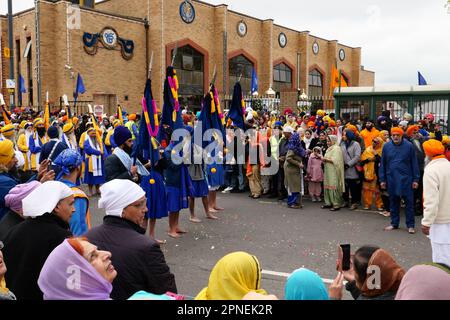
[{"left": 86, "top": 216, "right": 177, "bottom": 300}]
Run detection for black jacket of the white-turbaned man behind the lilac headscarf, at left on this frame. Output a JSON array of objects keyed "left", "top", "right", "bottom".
[{"left": 2, "top": 213, "right": 72, "bottom": 300}]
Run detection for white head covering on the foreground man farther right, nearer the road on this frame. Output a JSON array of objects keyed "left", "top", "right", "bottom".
[{"left": 98, "top": 179, "right": 145, "bottom": 217}]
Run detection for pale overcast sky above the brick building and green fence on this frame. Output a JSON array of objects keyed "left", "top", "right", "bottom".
[{"left": 0, "top": 0, "right": 450, "bottom": 85}]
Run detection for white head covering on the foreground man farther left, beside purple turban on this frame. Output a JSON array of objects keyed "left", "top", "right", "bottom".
[{"left": 22, "top": 181, "right": 73, "bottom": 218}]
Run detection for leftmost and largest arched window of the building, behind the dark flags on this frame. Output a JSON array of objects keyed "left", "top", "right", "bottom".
[{"left": 171, "top": 45, "right": 205, "bottom": 109}]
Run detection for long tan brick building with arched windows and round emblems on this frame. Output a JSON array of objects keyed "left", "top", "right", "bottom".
[{"left": 0, "top": 0, "right": 375, "bottom": 113}]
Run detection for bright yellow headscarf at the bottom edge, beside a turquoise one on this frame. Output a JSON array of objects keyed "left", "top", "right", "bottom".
[{"left": 195, "top": 252, "right": 267, "bottom": 300}]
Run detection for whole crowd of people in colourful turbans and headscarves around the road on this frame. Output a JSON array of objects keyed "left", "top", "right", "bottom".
[{"left": 0, "top": 102, "right": 450, "bottom": 300}]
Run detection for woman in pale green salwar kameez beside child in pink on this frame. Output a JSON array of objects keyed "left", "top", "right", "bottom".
[{"left": 322, "top": 135, "right": 345, "bottom": 211}]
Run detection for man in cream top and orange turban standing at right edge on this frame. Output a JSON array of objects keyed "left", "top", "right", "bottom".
[{"left": 422, "top": 139, "right": 450, "bottom": 266}]
